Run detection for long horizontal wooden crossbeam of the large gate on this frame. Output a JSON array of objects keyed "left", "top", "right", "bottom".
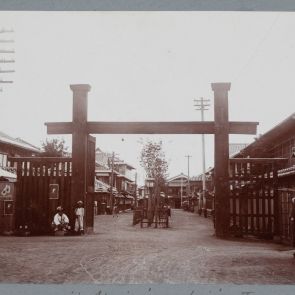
[{"left": 45, "top": 121, "right": 258, "bottom": 134}]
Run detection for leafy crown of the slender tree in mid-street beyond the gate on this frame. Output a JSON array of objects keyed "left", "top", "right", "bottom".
[{"left": 140, "top": 140, "right": 168, "bottom": 192}]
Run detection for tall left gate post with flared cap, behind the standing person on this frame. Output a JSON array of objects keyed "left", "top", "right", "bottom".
[{"left": 70, "top": 84, "right": 90, "bottom": 228}]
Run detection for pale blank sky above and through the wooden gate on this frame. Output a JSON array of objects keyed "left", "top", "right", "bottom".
[{"left": 0, "top": 11, "right": 295, "bottom": 183}]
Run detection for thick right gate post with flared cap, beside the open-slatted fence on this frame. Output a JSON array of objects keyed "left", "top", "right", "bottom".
[{"left": 211, "top": 83, "right": 230, "bottom": 238}]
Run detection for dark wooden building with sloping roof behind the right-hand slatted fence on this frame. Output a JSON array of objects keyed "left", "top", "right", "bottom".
[{"left": 235, "top": 113, "right": 295, "bottom": 243}]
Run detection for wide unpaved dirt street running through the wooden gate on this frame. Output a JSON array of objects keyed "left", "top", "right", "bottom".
[{"left": 0, "top": 210, "right": 295, "bottom": 284}]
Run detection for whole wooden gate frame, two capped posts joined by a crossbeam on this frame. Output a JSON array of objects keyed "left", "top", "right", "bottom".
[{"left": 45, "top": 83, "right": 258, "bottom": 237}]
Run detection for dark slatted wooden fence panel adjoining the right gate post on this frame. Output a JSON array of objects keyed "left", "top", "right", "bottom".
[{"left": 229, "top": 158, "right": 284, "bottom": 238}]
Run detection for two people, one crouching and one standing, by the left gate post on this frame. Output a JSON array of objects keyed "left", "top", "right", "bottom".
[{"left": 52, "top": 201, "right": 84, "bottom": 234}]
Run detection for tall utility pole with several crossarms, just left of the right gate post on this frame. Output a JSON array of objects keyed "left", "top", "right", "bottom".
[{"left": 194, "top": 97, "right": 210, "bottom": 213}]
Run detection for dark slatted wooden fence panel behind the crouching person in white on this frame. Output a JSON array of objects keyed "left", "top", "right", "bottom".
[{"left": 11, "top": 157, "right": 72, "bottom": 234}]
